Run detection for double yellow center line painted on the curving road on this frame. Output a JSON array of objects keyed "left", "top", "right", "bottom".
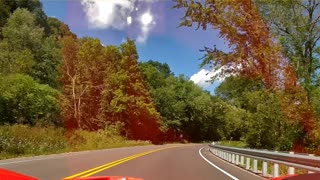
[{"left": 63, "top": 146, "right": 178, "bottom": 180}]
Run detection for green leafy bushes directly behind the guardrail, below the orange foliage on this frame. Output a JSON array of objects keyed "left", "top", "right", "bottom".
[{"left": 216, "top": 76, "right": 302, "bottom": 150}]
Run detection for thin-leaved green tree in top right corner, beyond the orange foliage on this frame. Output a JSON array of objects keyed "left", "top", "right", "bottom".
[{"left": 255, "top": 0, "right": 320, "bottom": 103}]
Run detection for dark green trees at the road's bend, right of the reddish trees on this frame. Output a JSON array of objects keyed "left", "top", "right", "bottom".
[{"left": 139, "top": 61, "right": 222, "bottom": 142}]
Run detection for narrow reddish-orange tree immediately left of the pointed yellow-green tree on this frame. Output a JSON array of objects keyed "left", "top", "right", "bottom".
[{"left": 77, "top": 38, "right": 108, "bottom": 129}]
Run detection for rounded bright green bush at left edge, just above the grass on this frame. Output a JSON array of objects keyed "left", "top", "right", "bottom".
[{"left": 0, "top": 74, "right": 60, "bottom": 125}]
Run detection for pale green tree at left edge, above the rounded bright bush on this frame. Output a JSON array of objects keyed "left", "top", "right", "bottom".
[{"left": 0, "top": 9, "right": 43, "bottom": 75}]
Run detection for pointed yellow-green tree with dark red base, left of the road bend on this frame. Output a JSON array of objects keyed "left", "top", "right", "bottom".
[{"left": 101, "top": 39, "right": 161, "bottom": 141}]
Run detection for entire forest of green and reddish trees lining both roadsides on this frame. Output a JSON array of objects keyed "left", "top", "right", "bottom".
[{"left": 0, "top": 0, "right": 320, "bottom": 157}]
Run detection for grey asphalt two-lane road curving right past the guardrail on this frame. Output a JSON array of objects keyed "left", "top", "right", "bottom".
[{"left": 0, "top": 144, "right": 262, "bottom": 180}]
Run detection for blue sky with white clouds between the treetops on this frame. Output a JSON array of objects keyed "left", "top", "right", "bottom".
[{"left": 41, "top": 0, "right": 228, "bottom": 93}]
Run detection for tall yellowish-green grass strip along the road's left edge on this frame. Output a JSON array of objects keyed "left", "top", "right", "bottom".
[{"left": 0, "top": 125, "right": 151, "bottom": 159}]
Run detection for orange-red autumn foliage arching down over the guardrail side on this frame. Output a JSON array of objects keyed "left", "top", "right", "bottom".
[{"left": 175, "top": 0, "right": 316, "bottom": 149}]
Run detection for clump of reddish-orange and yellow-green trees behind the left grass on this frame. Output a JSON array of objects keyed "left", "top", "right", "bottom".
[{"left": 61, "top": 36, "right": 160, "bottom": 141}]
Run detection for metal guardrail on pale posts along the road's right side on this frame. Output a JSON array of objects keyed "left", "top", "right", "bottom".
[{"left": 209, "top": 143, "right": 320, "bottom": 177}]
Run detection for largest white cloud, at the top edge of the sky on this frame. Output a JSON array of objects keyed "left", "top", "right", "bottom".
[{"left": 81, "top": 0, "right": 135, "bottom": 29}]
